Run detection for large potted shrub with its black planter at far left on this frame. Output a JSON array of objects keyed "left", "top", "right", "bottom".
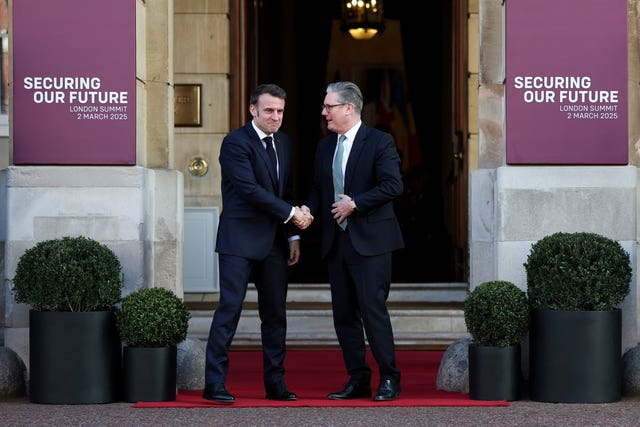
[{"left": 12, "top": 236, "right": 123, "bottom": 404}]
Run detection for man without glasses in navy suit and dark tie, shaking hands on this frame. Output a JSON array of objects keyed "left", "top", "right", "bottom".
[{"left": 203, "top": 84, "right": 311, "bottom": 403}]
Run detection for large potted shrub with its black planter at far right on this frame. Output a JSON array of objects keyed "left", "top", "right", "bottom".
[{"left": 524, "top": 232, "right": 632, "bottom": 403}]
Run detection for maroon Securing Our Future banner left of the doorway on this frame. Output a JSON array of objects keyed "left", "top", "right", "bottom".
[{"left": 12, "top": 0, "right": 136, "bottom": 165}]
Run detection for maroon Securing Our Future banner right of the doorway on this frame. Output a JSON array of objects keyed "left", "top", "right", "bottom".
[{"left": 506, "top": 0, "right": 629, "bottom": 165}]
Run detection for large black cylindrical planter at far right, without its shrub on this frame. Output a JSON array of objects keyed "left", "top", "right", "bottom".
[{"left": 529, "top": 310, "right": 622, "bottom": 403}]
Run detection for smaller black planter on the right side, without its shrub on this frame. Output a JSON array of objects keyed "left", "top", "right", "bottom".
[{"left": 469, "top": 344, "right": 522, "bottom": 400}]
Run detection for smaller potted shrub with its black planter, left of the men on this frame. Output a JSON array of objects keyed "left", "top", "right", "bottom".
[{"left": 116, "top": 288, "right": 191, "bottom": 402}]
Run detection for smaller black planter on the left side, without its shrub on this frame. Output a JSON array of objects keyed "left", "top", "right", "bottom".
[{"left": 122, "top": 346, "right": 177, "bottom": 402}]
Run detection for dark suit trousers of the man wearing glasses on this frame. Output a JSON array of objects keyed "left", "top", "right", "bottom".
[{"left": 328, "top": 226, "right": 400, "bottom": 381}]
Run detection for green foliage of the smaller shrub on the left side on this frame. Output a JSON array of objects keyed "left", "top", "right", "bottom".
[{"left": 116, "top": 288, "right": 191, "bottom": 347}]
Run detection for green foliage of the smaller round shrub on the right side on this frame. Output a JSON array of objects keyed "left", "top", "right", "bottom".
[{"left": 464, "top": 280, "right": 529, "bottom": 347}]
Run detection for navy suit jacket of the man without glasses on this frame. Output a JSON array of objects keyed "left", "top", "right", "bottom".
[{"left": 216, "top": 123, "right": 296, "bottom": 259}]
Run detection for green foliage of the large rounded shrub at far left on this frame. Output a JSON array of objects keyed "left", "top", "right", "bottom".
[{"left": 12, "top": 236, "right": 123, "bottom": 311}]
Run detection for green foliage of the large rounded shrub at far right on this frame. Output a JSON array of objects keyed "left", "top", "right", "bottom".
[{"left": 524, "top": 232, "right": 632, "bottom": 311}]
